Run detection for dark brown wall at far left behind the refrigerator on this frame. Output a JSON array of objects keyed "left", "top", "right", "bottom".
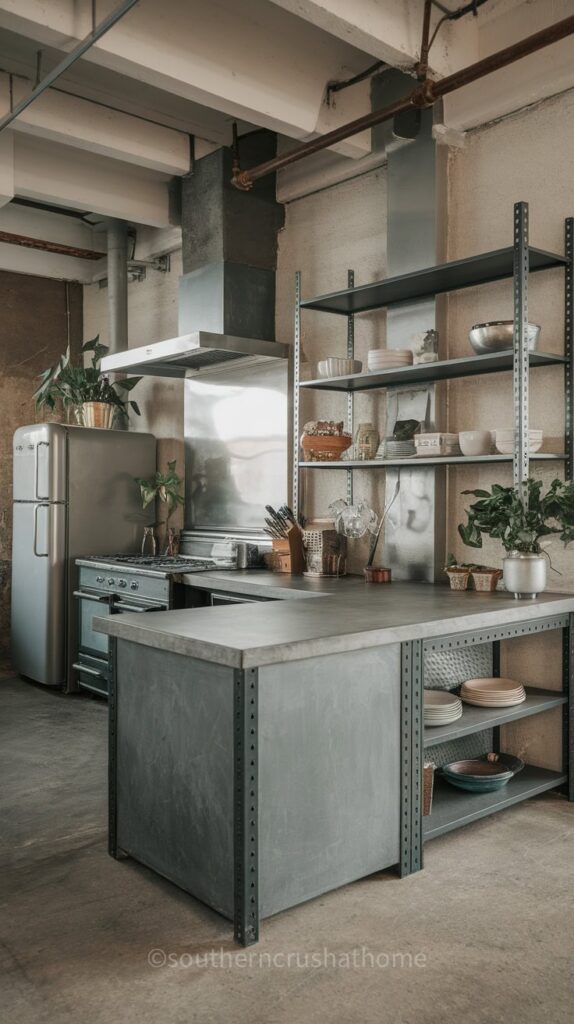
[{"left": 0, "top": 271, "right": 82, "bottom": 656}]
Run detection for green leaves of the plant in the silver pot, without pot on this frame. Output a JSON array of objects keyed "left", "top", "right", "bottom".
[{"left": 458, "top": 480, "right": 574, "bottom": 554}]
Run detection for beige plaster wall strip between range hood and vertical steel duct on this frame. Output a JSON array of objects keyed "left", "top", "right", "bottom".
[{"left": 276, "top": 169, "right": 387, "bottom": 570}]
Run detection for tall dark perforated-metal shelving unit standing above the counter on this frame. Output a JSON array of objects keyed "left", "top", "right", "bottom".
[{"left": 293, "top": 203, "right": 574, "bottom": 520}]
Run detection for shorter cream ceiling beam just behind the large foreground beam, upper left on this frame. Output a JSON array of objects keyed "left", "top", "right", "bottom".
[{"left": 0, "top": 74, "right": 190, "bottom": 175}]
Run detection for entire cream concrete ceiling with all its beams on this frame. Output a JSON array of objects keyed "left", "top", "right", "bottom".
[{"left": 0, "top": 0, "right": 574, "bottom": 274}]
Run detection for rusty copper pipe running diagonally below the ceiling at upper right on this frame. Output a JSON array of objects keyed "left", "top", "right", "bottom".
[{"left": 231, "top": 15, "right": 574, "bottom": 191}]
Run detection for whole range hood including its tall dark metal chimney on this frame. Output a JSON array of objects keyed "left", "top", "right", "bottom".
[{"left": 102, "top": 131, "right": 289, "bottom": 377}]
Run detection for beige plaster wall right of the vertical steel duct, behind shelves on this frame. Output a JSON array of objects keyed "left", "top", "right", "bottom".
[{"left": 446, "top": 92, "right": 574, "bottom": 769}]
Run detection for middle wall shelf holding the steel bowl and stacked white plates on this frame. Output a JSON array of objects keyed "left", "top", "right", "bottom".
[{"left": 299, "top": 349, "right": 567, "bottom": 392}]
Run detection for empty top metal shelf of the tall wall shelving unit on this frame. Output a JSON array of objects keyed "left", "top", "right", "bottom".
[{"left": 301, "top": 246, "right": 568, "bottom": 316}]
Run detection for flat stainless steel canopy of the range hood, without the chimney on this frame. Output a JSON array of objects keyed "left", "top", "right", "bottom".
[{"left": 101, "top": 331, "right": 289, "bottom": 377}]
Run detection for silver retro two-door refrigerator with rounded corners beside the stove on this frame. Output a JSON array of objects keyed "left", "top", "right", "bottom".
[{"left": 11, "top": 423, "right": 156, "bottom": 691}]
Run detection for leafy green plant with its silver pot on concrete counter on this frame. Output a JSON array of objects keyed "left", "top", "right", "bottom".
[{"left": 458, "top": 480, "right": 574, "bottom": 597}]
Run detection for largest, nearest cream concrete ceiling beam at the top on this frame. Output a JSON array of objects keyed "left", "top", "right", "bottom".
[{"left": 0, "top": 0, "right": 367, "bottom": 157}]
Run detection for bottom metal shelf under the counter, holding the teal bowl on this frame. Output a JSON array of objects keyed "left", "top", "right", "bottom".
[{"left": 423, "top": 765, "right": 567, "bottom": 841}]
